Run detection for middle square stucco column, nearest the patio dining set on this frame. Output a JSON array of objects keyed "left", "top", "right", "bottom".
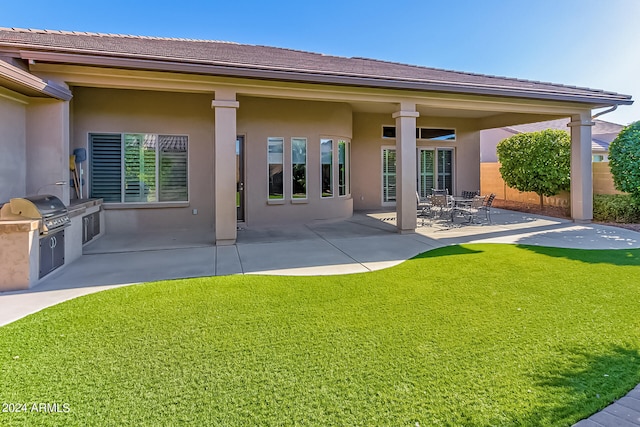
[{"left": 392, "top": 103, "right": 420, "bottom": 233}]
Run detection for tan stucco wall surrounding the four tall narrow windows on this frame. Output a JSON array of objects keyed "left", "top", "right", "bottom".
[{"left": 238, "top": 96, "right": 354, "bottom": 226}]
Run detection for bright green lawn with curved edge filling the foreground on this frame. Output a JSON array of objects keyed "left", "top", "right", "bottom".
[{"left": 0, "top": 244, "right": 640, "bottom": 427}]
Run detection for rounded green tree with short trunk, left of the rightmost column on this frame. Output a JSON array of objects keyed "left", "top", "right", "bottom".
[{"left": 497, "top": 129, "right": 571, "bottom": 207}]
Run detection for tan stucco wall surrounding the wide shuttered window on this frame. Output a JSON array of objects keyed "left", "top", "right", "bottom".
[{"left": 71, "top": 87, "right": 214, "bottom": 232}]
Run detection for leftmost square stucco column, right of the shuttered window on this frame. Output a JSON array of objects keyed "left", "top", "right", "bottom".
[{"left": 211, "top": 92, "right": 240, "bottom": 246}]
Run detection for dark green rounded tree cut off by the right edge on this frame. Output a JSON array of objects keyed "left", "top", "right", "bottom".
[{"left": 609, "top": 121, "right": 640, "bottom": 203}]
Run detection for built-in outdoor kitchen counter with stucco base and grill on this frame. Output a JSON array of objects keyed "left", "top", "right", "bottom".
[{"left": 0, "top": 195, "right": 104, "bottom": 292}]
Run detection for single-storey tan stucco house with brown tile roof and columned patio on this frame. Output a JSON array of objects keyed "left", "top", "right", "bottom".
[{"left": 0, "top": 28, "right": 632, "bottom": 254}]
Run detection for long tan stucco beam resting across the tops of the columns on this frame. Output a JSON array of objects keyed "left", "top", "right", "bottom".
[{"left": 30, "top": 62, "right": 604, "bottom": 123}]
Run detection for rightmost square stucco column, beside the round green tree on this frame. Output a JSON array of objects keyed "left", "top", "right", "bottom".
[{"left": 568, "top": 112, "right": 594, "bottom": 223}]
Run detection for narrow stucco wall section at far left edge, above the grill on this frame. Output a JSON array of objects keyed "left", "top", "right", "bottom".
[{"left": 0, "top": 91, "right": 27, "bottom": 204}]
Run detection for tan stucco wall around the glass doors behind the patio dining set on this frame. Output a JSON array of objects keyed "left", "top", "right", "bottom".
[{"left": 351, "top": 113, "right": 480, "bottom": 210}]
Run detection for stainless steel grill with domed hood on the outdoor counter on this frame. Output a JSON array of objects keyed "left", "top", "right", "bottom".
[{"left": 0, "top": 194, "right": 71, "bottom": 235}]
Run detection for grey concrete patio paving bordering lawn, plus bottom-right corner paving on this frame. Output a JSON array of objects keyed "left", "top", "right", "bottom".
[{"left": 0, "top": 209, "right": 640, "bottom": 427}]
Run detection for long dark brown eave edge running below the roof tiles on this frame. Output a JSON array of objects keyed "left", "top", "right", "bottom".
[{"left": 20, "top": 50, "right": 633, "bottom": 108}]
